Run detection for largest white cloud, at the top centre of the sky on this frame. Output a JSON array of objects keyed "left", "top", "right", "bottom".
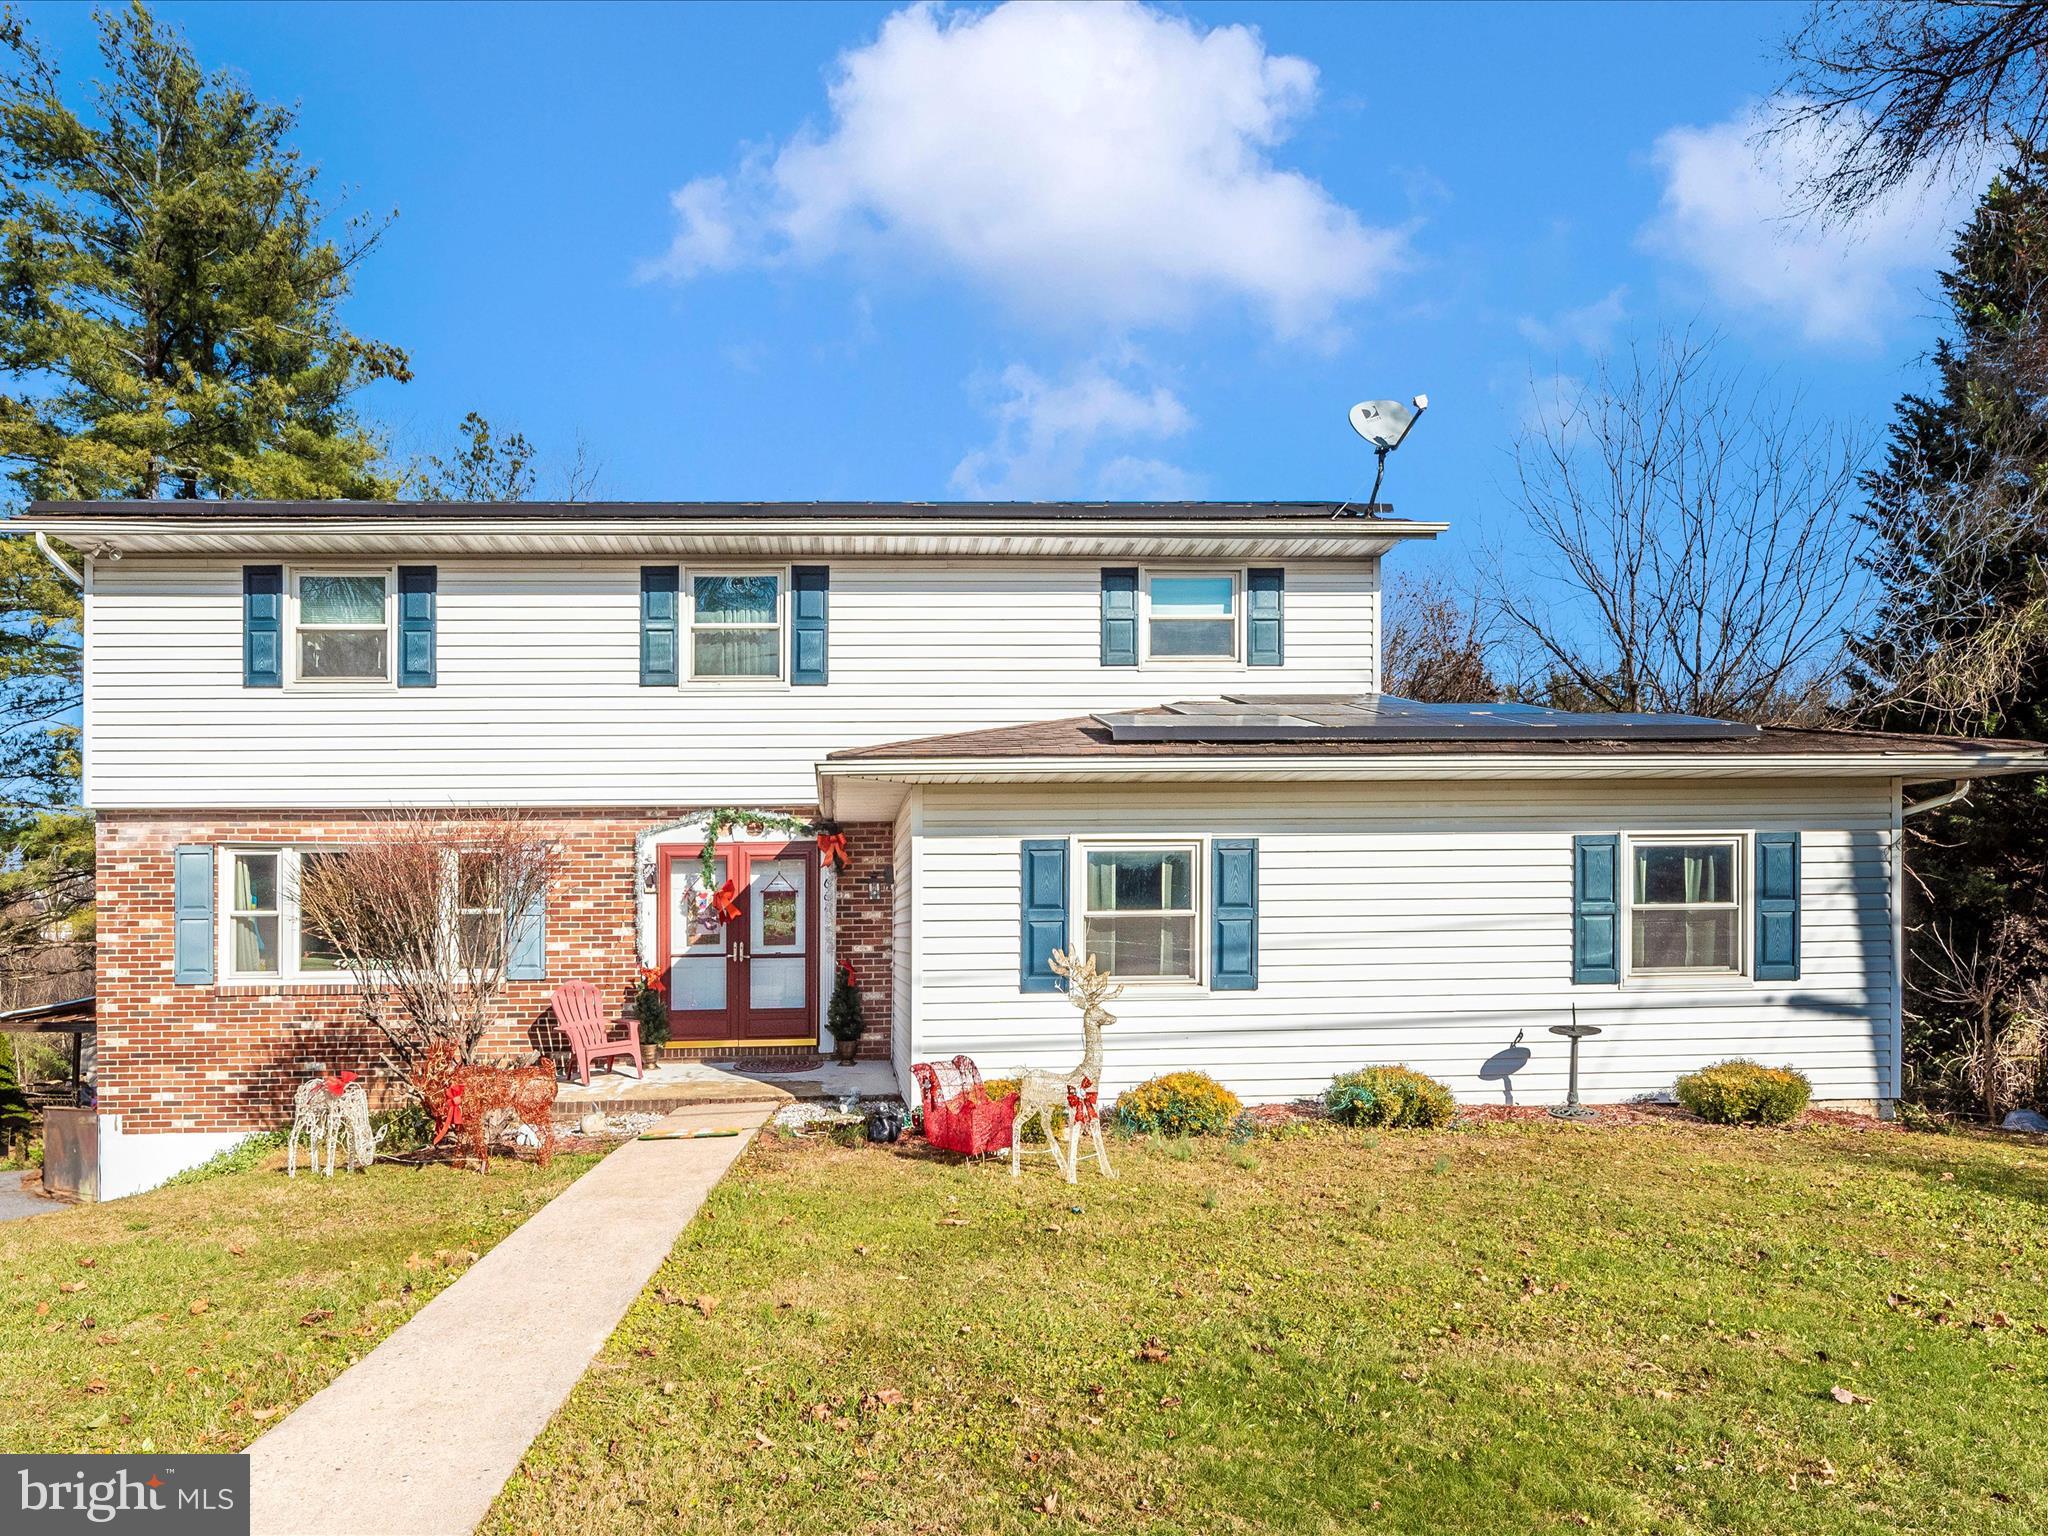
[{"left": 649, "top": 0, "right": 1407, "bottom": 334}]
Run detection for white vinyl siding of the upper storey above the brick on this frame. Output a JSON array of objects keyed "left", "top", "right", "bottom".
[{"left": 84, "top": 555, "right": 1378, "bottom": 809}]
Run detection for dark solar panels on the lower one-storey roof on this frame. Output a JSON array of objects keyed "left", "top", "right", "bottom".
[{"left": 1096, "top": 694, "right": 1761, "bottom": 741}]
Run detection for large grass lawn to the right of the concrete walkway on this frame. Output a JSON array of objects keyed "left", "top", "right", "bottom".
[{"left": 485, "top": 1122, "right": 2048, "bottom": 1534}]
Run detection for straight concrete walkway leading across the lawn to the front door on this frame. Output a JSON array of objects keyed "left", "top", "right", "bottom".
[{"left": 250, "top": 1102, "right": 776, "bottom": 1536}]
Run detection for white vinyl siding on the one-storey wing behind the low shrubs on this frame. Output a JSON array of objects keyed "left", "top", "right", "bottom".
[{"left": 911, "top": 780, "right": 1896, "bottom": 1104}]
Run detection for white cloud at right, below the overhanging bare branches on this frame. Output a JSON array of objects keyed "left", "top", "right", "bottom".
[{"left": 1642, "top": 102, "right": 1989, "bottom": 346}]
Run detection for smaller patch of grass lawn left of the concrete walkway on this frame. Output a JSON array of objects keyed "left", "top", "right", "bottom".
[{"left": 0, "top": 1153, "right": 594, "bottom": 1452}]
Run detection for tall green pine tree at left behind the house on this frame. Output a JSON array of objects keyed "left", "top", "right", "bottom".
[{"left": 0, "top": 4, "right": 410, "bottom": 831}]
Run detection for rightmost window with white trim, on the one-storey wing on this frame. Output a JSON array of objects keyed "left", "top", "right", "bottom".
[{"left": 1628, "top": 838, "right": 1743, "bottom": 977}]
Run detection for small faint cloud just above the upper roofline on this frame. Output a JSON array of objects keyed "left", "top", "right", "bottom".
[{"left": 952, "top": 362, "right": 1196, "bottom": 502}]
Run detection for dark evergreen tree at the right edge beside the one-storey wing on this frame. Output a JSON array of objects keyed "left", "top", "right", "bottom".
[{"left": 1849, "top": 145, "right": 2048, "bottom": 1097}]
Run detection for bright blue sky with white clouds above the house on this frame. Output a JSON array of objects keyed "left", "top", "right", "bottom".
[{"left": 31, "top": 4, "right": 1990, "bottom": 581}]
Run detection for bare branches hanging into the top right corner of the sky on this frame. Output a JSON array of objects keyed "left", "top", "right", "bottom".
[{"left": 1769, "top": 0, "right": 2048, "bottom": 219}]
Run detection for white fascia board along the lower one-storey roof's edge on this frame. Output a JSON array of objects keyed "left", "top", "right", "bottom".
[{"left": 817, "top": 752, "right": 2048, "bottom": 791}]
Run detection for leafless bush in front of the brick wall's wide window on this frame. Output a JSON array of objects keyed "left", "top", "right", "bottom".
[{"left": 297, "top": 811, "right": 553, "bottom": 1081}]
